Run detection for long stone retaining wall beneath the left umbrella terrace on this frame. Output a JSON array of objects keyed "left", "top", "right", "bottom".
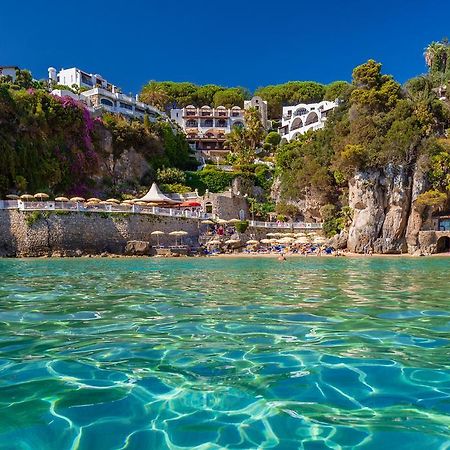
[{"left": 0, "top": 210, "right": 199, "bottom": 256}]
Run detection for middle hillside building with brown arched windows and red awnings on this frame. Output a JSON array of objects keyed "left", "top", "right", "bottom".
[{"left": 170, "top": 105, "right": 244, "bottom": 158}]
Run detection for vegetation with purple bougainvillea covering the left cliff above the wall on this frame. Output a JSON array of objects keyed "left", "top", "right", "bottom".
[{"left": 0, "top": 71, "right": 197, "bottom": 196}]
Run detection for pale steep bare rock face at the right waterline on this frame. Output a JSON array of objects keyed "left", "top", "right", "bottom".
[{"left": 347, "top": 163, "right": 426, "bottom": 253}]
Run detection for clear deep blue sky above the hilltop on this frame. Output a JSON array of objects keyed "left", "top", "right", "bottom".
[{"left": 0, "top": 0, "right": 450, "bottom": 92}]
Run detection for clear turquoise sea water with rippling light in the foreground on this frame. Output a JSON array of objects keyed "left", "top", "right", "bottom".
[{"left": 0, "top": 258, "right": 450, "bottom": 450}]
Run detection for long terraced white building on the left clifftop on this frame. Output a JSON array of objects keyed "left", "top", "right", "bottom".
[{"left": 48, "top": 67, "right": 163, "bottom": 121}]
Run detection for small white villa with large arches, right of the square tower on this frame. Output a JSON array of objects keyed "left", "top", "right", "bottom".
[{"left": 278, "top": 100, "right": 338, "bottom": 142}]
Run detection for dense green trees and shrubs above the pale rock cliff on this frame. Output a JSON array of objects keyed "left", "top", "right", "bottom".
[{"left": 276, "top": 54, "right": 450, "bottom": 227}]
